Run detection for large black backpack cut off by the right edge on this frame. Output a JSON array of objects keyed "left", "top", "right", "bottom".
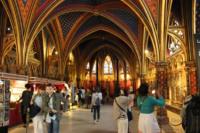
[{"left": 183, "top": 96, "right": 200, "bottom": 133}]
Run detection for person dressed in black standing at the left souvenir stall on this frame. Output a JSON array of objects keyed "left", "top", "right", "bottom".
[{"left": 18, "top": 84, "right": 33, "bottom": 127}]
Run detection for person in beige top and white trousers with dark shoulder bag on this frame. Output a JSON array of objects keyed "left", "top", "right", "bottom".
[{"left": 113, "top": 89, "right": 131, "bottom": 133}]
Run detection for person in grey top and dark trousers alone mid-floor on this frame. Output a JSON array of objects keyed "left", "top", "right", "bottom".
[{"left": 91, "top": 89, "right": 102, "bottom": 123}]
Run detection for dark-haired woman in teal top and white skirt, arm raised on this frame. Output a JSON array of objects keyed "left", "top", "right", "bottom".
[{"left": 137, "top": 83, "right": 165, "bottom": 133}]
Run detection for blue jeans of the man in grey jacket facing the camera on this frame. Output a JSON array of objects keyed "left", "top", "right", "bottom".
[{"left": 47, "top": 118, "right": 60, "bottom": 133}]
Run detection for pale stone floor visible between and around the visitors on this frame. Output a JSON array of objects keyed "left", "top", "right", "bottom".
[{"left": 9, "top": 105, "right": 183, "bottom": 133}]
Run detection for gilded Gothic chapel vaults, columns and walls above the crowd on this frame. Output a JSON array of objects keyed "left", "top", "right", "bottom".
[{"left": 0, "top": 0, "right": 200, "bottom": 109}]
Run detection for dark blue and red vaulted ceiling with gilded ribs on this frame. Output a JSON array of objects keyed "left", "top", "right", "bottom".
[{"left": 2, "top": 0, "right": 189, "bottom": 79}]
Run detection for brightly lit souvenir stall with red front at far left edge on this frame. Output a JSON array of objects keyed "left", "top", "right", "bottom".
[{"left": 0, "top": 73, "right": 28, "bottom": 126}]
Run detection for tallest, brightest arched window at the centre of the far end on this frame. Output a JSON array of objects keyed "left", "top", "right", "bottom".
[{"left": 104, "top": 56, "right": 113, "bottom": 74}]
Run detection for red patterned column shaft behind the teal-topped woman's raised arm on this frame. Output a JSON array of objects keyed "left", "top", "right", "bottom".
[{"left": 156, "top": 62, "right": 169, "bottom": 124}]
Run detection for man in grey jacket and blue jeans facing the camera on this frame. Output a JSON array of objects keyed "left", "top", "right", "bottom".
[{"left": 46, "top": 84, "right": 66, "bottom": 133}]
